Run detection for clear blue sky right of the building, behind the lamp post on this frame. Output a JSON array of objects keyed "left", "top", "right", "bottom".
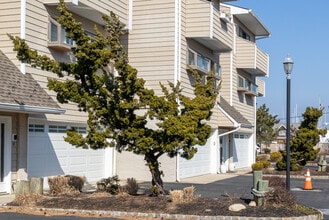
[{"left": 230, "top": 0, "right": 329, "bottom": 122}]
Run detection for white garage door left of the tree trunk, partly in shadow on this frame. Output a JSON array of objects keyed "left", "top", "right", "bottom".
[{"left": 27, "top": 124, "right": 109, "bottom": 185}]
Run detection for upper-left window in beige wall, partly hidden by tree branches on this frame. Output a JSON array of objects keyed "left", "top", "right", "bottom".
[{"left": 48, "top": 18, "right": 74, "bottom": 51}]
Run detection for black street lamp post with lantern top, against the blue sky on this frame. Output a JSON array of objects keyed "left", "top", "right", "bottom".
[{"left": 283, "top": 56, "right": 294, "bottom": 191}]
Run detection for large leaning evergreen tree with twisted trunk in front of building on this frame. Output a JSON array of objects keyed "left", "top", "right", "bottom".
[{"left": 9, "top": 0, "right": 218, "bottom": 195}]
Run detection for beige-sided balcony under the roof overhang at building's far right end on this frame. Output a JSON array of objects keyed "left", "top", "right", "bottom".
[{"left": 236, "top": 37, "right": 269, "bottom": 76}]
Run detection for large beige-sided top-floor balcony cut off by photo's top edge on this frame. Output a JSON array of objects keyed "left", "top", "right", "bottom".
[{"left": 186, "top": 0, "right": 233, "bottom": 52}]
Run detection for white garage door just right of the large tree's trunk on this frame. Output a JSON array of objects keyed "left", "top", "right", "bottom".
[{"left": 179, "top": 144, "right": 212, "bottom": 178}]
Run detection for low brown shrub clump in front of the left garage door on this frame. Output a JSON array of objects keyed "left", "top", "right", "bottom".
[{"left": 48, "top": 175, "right": 86, "bottom": 195}]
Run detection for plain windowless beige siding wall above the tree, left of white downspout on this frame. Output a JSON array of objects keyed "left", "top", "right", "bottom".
[{"left": 128, "top": 0, "right": 175, "bottom": 94}]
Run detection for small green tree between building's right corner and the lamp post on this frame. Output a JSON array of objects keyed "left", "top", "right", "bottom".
[{"left": 256, "top": 104, "right": 280, "bottom": 149}]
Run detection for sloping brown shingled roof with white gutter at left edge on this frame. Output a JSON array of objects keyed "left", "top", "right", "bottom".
[{"left": 0, "top": 50, "right": 65, "bottom": 114}]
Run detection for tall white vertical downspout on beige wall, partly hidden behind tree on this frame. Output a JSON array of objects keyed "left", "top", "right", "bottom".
[{"left": 174, "top": 0, "right": 182, "bottom": 182}]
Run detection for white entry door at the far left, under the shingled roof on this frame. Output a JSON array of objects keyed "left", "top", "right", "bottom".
[{"left": 0, "top": 116, "right": 11, "bottom": 193}]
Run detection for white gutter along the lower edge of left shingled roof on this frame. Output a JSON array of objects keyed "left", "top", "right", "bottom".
[{"left": 0, "top": 103, "right": 66, "bottom": 114}]
